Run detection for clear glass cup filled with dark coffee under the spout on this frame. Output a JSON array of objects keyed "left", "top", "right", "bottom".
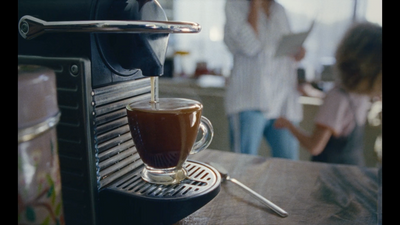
[{"left": 126, "top": 98, "right": 214, "bottom": 185}]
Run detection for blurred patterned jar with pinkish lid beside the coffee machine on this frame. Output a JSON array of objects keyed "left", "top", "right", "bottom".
[{"left": 18, "top": 65, "right": 65, "bottom": 225}]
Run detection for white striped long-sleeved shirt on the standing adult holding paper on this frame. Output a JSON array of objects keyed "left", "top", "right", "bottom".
[{"left": 224, "top": 0, "right": 303, "bottom": 122}]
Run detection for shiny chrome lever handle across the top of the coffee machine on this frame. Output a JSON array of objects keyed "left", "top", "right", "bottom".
[{"left": 18, "top": 15, "right": 201, "bottom": 40}]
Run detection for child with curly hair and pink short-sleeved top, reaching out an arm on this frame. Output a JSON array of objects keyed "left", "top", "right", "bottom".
[{"left": 274, "top": 22, "right": 382, "bottom": 166}]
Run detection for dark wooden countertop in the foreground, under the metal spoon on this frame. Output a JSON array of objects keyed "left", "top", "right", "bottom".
[{"left": 175, "top": 150, "right": 382, "bottom": 225}]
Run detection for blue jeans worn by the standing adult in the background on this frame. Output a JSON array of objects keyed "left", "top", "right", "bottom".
[{"left": 228, "top": 110, "right": 299, "bottom": 160}]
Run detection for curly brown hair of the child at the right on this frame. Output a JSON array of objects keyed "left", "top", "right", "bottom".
[{"left": 335, "top": 22, "right": 382, "bottom": 94}]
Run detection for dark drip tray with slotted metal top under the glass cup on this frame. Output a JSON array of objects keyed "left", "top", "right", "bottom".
[{"left": 99, "top": 160, "right": 221, "bottom": 224}]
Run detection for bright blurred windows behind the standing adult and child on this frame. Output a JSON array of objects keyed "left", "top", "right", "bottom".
[{"left": 159, "top": 0, "right": 382, "bottom": 81}]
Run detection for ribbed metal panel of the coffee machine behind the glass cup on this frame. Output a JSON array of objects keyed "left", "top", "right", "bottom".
[{"left": 92, "top": 78, "right": 150, "bottom": 189}]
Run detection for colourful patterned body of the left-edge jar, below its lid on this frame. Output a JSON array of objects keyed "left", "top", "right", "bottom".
[{"left": 18, "top": 129, "right": 65, "bottom": 225}]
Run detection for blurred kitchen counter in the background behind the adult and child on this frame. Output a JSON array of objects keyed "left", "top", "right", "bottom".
[{"left": 158, "top": 75, "right": 382, "bottom": 166}]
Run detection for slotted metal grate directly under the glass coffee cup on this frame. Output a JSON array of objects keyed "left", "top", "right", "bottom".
[{"left": 107, "top": 160, "right": 221, "bottom": 200}]
